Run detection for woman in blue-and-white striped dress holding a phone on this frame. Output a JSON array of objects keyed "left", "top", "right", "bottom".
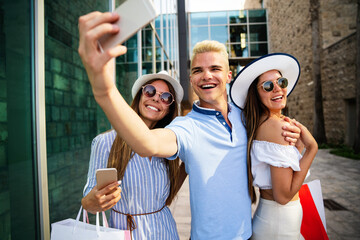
[{"left": 82, "top": 71, "right": 185, "bottom": 240}]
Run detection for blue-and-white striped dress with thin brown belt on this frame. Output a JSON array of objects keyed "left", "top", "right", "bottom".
[{"left": 84, "top": 130, "right": 179, "bottom": 240}]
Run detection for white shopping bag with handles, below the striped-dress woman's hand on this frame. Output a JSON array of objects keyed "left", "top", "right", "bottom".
[{"left": 51, "top": 207, "right": 131, "bottom": 240}]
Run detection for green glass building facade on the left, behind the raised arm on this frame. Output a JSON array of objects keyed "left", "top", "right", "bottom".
[{"left": 0, "top": 0, "right": 179, "bottom": 240}]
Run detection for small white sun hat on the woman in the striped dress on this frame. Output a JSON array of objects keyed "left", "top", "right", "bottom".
[{"left": 131, "top": 71, "right": 184, "bottom": 103}]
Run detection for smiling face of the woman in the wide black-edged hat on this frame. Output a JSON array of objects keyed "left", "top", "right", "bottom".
[{"left": 257, "top": 70, "right": 287, "bottom": 114}]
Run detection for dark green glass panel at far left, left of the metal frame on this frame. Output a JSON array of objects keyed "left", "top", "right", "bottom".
[{"left": 0, "top": 0, "right": 40, "bottom": 240}]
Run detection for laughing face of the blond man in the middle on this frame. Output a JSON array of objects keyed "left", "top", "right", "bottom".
[{"left": 190, "top": 52, "right": 231, "bottom": 108}]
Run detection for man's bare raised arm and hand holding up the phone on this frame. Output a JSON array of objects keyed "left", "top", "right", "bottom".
[{"left": 78, "top": 12, "right": 177, "bottom": 157}]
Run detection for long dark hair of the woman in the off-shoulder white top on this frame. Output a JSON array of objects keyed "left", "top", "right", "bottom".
[{"left": 241, "top": 76, "right": 270, "bottom": 203}]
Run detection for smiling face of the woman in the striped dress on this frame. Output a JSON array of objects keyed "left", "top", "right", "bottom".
[{"left": 139, "top": 80, "right": 175, "bottom": 128}]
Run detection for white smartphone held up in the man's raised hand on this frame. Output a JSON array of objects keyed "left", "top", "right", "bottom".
[{"left": 99, "top": 0, "right": 159, "bottom": 51}]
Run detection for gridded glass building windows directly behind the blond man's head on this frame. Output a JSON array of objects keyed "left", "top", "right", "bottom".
[{"left": 188, "top": 9, "right": 268, "bottom": 59}]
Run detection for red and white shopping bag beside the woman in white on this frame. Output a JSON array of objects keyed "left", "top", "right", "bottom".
[{"left": 299, "top": 180, "right": 329, "bottom": 240}]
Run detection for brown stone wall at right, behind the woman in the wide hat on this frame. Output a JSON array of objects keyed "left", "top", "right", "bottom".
[{"left": 264, "top": 0, "right": 358, "bottom": 144}]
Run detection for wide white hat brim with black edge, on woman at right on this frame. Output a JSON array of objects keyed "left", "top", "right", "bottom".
[{"left": 230, "top": 53, "right": 300, "bottom": 109}]
